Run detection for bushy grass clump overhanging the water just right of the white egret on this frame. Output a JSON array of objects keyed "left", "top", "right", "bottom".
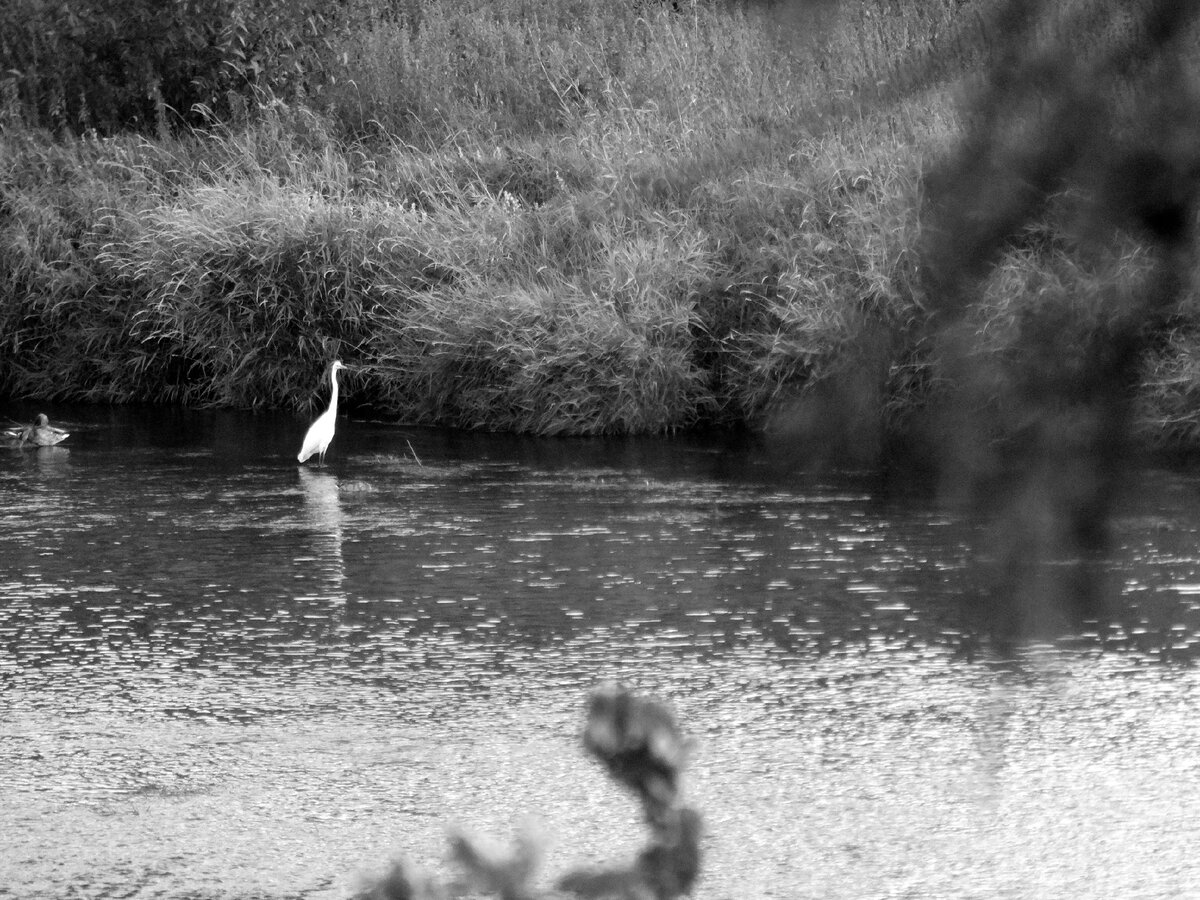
[{"left": 355, "top": 196, "right": 707, "bottom": 433}]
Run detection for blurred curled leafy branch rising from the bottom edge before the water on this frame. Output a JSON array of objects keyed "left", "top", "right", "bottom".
[{"left": 358, "top": 684, "right": 701, "bottom": 900}]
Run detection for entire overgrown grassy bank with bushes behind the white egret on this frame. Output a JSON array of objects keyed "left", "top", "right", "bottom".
[{"left": 0, "top": 0, "right": 1200, "bottom": 456}]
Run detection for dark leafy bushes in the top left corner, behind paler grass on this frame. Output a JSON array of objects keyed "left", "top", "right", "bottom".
[{"left": 0, "top": 0, "right": 372, "bottom": 133}]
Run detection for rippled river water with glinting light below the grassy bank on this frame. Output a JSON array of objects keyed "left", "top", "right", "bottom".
[{"left": 0, "top": 407, "right": 1200, "bottom": 900}]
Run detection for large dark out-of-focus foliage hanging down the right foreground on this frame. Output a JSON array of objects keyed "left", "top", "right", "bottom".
[{"left": 769, "top": 0, "right": 1200, "bottom": 647}]
